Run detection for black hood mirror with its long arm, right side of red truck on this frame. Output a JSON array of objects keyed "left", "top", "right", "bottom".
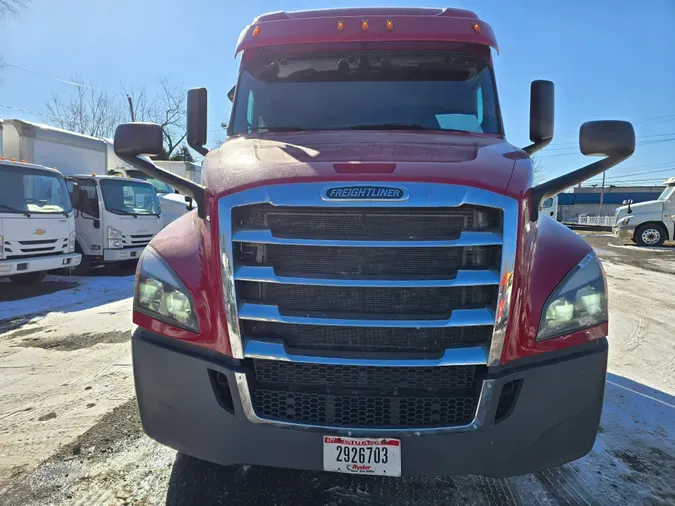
[{"left": 530, "top": 120, "right": 635, "bottom": 221}]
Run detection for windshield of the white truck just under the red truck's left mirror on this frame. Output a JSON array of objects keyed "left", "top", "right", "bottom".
[{"left": 101, "top": 178, "right": 159, "bottom": 215}]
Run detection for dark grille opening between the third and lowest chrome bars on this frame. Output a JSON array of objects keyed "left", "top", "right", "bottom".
[{"left": 241, "top": 320, "right": 492, "bottom": 356}]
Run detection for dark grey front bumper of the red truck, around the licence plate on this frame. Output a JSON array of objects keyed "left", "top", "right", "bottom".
[{"left": 132, "top": 328, "right": 607, "bottom": 477}]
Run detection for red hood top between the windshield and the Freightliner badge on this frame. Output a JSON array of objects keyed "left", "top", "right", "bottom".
[{"left": 209, "top": 131, "right": 527, "bottom": 196}]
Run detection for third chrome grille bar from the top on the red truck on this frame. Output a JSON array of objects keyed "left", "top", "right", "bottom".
[{"left": 239, "top": 303, "right": 495, "bottom": 329}]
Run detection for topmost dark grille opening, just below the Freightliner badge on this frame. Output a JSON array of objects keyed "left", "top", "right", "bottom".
[{"left": 232, "top": 204, "right": 501, "bottom": 241}]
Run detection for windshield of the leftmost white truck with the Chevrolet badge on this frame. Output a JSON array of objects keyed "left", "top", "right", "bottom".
[{"left": 0, "top": 164, "right": 72, "bottom": 214}]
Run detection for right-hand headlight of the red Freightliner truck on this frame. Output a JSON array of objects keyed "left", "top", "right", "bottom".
[{"left": 537, "top": 253, "right": 607, "bottom": 341}]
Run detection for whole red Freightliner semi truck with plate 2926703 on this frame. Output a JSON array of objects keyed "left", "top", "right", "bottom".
[{"left": 115, "top": 8, "right": 635, "bottom": 476}]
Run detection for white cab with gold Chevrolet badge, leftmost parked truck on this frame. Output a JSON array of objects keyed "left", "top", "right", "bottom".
[{"left": 0, "top": 157, "right": 81, "bottom": 284}]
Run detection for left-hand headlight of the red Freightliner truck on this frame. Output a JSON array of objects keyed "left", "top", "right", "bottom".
[{"left": 134, "top": 247, "right": 199, "bottom": 332}]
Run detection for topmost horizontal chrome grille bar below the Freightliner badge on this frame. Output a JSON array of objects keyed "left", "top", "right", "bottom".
[{"left": 232, "top": 230, "right": 502, "bottom": 248}]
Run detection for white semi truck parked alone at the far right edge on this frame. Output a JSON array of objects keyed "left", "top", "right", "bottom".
[{"left": 613, "top": 177, "right": 675, "bottom": 246}]
